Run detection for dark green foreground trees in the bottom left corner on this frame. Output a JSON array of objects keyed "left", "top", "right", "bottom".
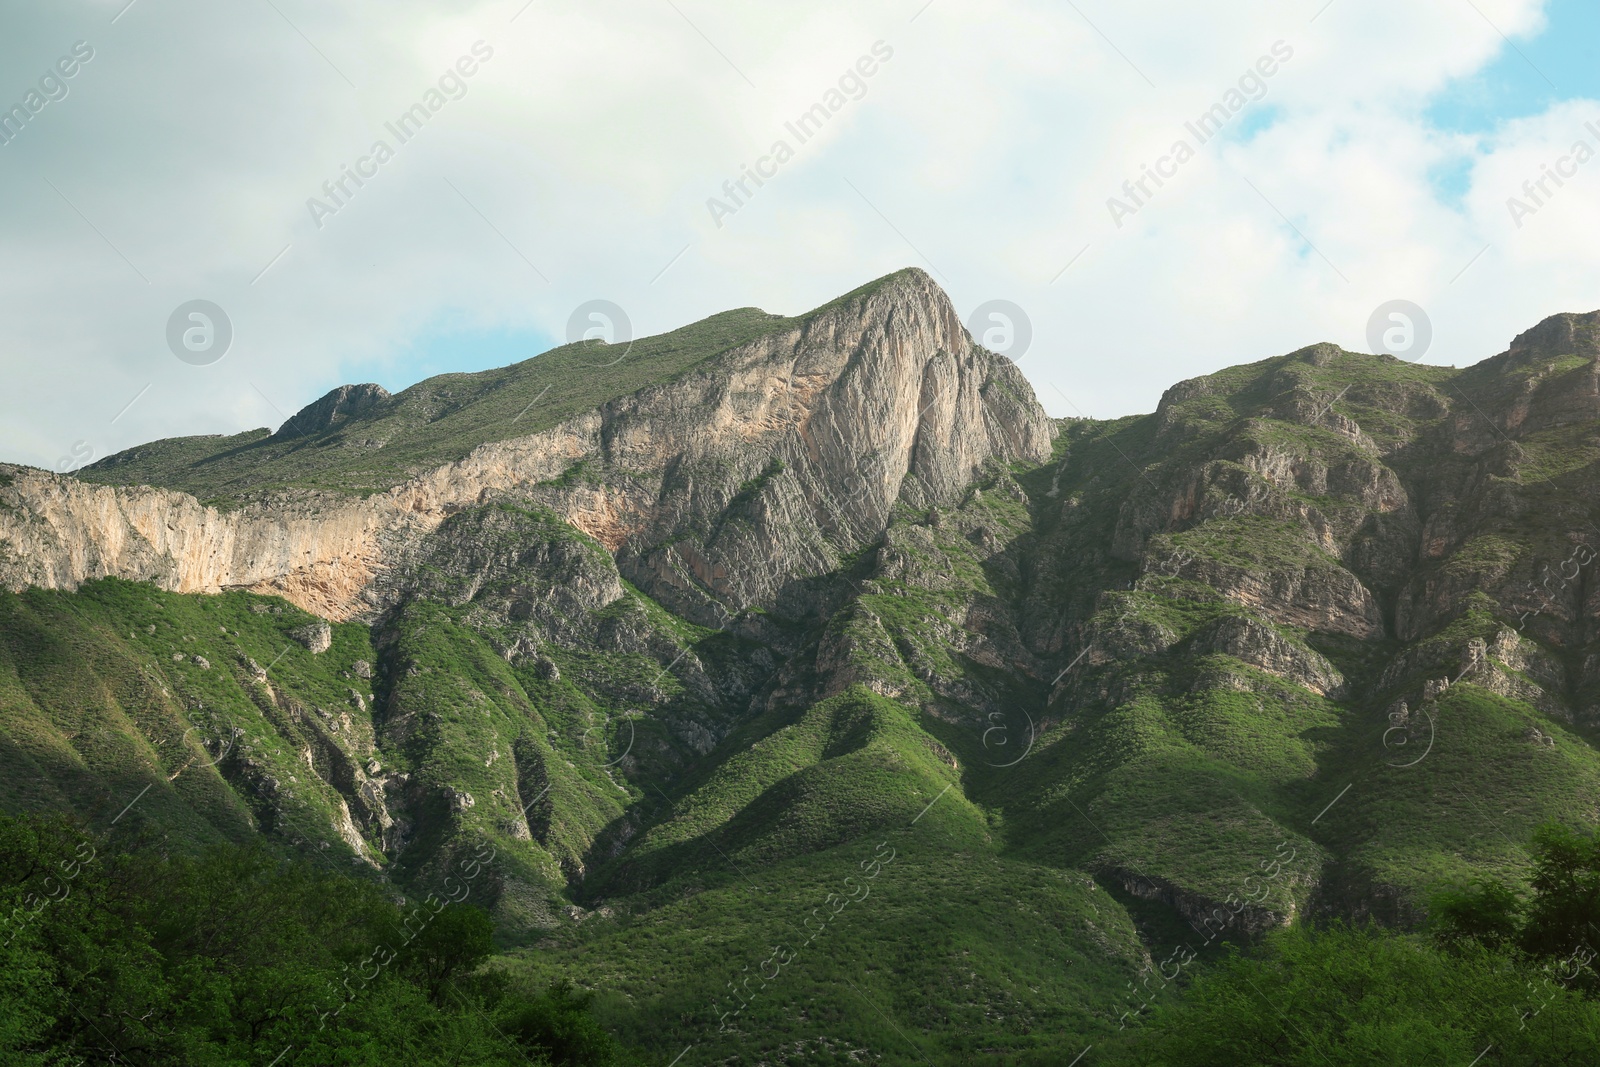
[{"left": 0, "top": 816, "right": 629, "bottom": 1067}]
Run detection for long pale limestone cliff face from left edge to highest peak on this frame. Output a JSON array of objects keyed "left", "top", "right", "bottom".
[{"left": 0, "top": 270, "right": 1054, "bottom": 619}]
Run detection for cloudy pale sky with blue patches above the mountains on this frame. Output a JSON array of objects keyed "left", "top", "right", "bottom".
[{"left": 0, "top": 0, "right": 1600, "bottom": 470}]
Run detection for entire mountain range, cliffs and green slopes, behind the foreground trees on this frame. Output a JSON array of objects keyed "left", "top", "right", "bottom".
[{"left": 0, "top": 270, "right": 1600, "bottom": 1062}]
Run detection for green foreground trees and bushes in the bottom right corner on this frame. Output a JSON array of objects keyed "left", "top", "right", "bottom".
[{"left": 1109, "top": 824, "right": 1600, "bottom": 1067}]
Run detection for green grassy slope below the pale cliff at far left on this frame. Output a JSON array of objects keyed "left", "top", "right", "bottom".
[{"left": 0, "top": 579, "right": 373, "bottom": 861}]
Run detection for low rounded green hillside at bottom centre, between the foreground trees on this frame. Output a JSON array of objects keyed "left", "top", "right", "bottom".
[{"left": 506, "top": 790, "right": 1142, "bottom": 1064}]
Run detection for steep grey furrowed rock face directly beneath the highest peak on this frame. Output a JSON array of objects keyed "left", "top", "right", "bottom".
[{"left": 518, "top": 272, "right": 1054, "bottom": 622}]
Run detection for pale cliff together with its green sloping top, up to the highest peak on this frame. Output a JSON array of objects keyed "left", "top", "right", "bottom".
[{"left": 0, "top": 270, "right": 1056, "bottom": 622}]
